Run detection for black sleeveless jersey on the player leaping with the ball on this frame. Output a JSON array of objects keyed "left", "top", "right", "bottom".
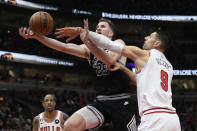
[{"left": 90, "top": 53, "right": 131, "bottom": 95}]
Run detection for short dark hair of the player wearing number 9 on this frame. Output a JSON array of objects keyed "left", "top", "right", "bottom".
[{"left": 156, "top": 30, "right": 172, "bottom": 50}]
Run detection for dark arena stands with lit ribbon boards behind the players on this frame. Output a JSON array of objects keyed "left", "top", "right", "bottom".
[{"left": 0, "top": 0, "right": 197, "bottom": 131}]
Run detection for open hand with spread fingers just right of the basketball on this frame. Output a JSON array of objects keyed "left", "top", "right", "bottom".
[{"left": 55, "top": 27, "right": 83, "bottom": 42}]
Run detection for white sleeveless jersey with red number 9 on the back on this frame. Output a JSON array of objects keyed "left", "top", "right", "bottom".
[{"left": 136, "top": 49, "right": 176, "bottom": 116}]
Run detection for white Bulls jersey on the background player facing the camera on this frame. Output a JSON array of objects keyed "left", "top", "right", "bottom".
[{"left": 38, "top": 110, "right": 63, "bottom": 131}]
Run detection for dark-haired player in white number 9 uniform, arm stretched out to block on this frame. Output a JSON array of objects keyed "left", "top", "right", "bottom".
[{"left": 57, "top": 21, "right": 181, "bottom": 131}]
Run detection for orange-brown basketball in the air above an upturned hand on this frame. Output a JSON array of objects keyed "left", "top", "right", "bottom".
[{"left": 29, "top": 11, "right": 54, "bottom": 35}]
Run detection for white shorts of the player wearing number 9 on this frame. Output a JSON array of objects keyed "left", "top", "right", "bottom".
[{"left": 138, "top": 113, "right": 181, "bottom": 131}]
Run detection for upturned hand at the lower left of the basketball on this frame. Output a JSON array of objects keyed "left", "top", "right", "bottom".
[{"left": 19, "top": 27, "right": 38, "bottom": 39}]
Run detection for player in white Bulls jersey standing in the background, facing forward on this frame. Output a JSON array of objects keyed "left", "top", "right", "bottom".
[{"left": 33, "top": 94, "right": 68, "bottom": 131}]
